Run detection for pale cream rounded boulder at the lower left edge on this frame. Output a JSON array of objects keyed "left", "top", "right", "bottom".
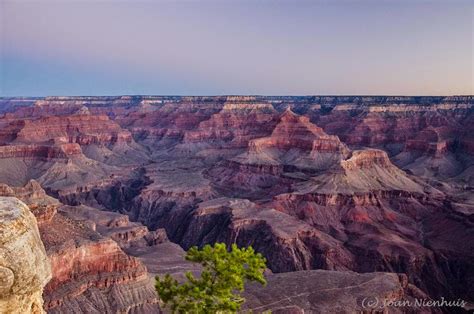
[{"left": 0, "top": 197, "right": 51, "bottom": 313}]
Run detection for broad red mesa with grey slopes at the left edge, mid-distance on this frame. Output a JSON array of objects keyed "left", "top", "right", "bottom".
[{"left": 0, "top": 108, "right": 147, "bottom": 193}]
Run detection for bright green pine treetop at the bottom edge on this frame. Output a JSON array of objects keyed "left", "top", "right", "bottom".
[{"left": 155, "top": 243, "right": 266, "bottom": 313}]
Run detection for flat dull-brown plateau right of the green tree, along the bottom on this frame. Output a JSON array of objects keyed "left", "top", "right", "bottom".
[{"left": 243, "top": 270, "right": 428, "bottom": 314}]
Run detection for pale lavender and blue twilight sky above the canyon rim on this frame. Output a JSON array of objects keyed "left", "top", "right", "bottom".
[{"left": 0, "top": 0, "right": 474, "bottom": 96}]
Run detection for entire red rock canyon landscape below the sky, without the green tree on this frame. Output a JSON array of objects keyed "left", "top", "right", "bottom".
[{"left": 0, "top": 96, "right": 474, "bottom": 313}]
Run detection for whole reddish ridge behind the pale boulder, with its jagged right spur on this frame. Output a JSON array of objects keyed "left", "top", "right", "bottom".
[{"left": 0, "top": 181, "right": 161, "bottom": 313}]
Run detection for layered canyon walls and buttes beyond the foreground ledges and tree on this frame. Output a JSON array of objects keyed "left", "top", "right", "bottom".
[{"left": 0, "top": 96, "right": 474, "bottom": 310}]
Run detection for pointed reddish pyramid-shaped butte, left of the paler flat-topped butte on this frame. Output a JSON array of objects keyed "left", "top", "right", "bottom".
[{"left": 208, "top": 109, "right": 348, "bottom": 195}]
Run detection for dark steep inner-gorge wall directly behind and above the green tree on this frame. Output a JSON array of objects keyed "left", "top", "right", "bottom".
[{"left": 144, "top": 198, "right": 352, "bottom": 272}]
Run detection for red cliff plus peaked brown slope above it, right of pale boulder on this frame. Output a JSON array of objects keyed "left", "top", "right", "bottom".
[{"left": 40, "top": 209, "right": 158, "bottom": 313}]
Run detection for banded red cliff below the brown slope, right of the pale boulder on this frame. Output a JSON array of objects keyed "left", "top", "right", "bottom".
[{"left": 43, "top": 236, "right": 158, "bottom": 313}]
